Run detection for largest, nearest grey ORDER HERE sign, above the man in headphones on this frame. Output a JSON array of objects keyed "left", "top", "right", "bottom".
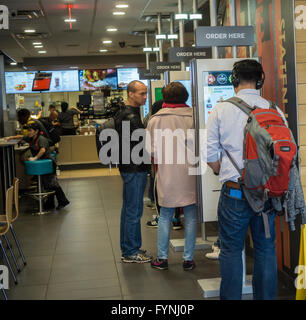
[{"left": 196, "top": 26, "right": 254, "bottom": 47}]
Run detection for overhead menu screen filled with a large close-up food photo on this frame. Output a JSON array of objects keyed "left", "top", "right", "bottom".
[{"left": 79, "top": 69, "right": 118, "bottom": 91}]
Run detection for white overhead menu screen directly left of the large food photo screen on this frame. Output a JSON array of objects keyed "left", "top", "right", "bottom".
[{"left": 46, "top": 70, "right": 80, "bottom": 92}]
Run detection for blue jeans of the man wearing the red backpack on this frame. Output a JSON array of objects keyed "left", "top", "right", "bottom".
[{"left": 218, "top": 184, "right": 277, "bottom": 300}]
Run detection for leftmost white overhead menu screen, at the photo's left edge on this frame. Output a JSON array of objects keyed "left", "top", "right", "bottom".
[{"left": 5, "top": 71, "right": 36, "bottom": 94}]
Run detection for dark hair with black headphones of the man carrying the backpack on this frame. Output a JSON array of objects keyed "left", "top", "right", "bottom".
[{"left": 232, "top": 59, "right": 265, "bottom": 89}]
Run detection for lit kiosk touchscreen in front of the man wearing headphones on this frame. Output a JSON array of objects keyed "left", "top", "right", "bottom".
[{"left": 203, "top": 71, "right": 235, "bottom": 122}]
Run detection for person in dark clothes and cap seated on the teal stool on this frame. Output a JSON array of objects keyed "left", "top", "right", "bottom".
[{"left": 22, "top": 123, "right": 70, "bottom": 210}]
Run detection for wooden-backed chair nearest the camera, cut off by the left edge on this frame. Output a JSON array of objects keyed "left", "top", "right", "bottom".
[{"left": 0, "top": 186, "right": 18, "bottom": 297}]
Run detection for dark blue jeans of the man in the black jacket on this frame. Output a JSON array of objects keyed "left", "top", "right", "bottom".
[{"left": 120, "top": 172, "right": 147, "bottom": 256}]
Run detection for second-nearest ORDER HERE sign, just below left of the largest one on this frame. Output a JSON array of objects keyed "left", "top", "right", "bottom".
[{"left": 168, "top": 47, "right": 211, "bottom": 62}]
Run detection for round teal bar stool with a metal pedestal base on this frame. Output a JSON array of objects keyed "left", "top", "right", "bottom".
[{"left": 24, "top": 159, "right": 55, "bottom": 215}]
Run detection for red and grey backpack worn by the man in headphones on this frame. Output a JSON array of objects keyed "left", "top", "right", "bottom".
[{"left": 226, "top": 97, "right": 297, "bottom": 213}]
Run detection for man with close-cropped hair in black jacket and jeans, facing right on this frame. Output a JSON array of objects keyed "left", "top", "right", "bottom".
[{"left": 116, "top": 81, "right": 152, "bottom": 263}]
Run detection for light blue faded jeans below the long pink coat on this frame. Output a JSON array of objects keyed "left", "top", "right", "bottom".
[{"left": 157, "top": 204, "right": 198, "bottom": 261}]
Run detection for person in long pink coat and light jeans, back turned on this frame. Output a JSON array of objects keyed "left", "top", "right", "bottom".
[{"left": 147, "top": 82, "right": 197, "bottom": 270}]
